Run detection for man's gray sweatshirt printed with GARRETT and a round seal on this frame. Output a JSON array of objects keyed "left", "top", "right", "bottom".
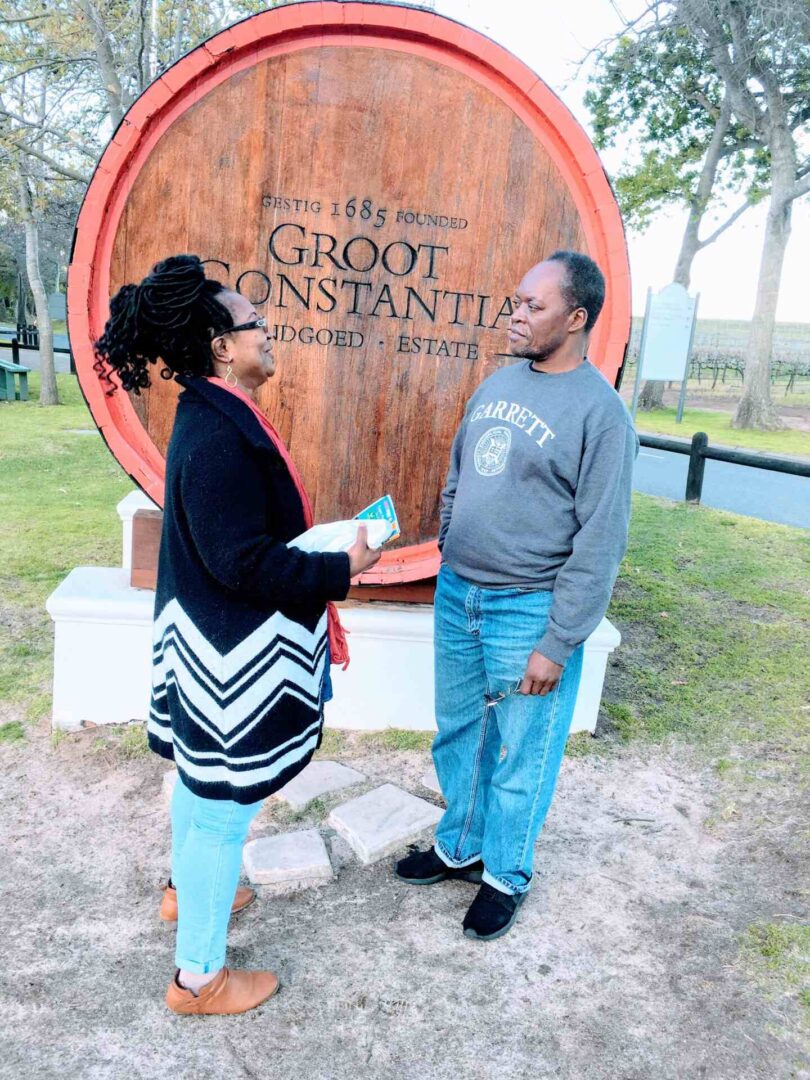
[{"left": 438, "top": 360, "right": 638, "bottom": 664}]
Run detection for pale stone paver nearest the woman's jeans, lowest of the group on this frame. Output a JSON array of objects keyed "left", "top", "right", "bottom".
[{"left": 243, "top": 828, "right": 335, "bottom": 893}]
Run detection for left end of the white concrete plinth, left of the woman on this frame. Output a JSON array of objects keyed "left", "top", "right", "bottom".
[{"left": 45, "top": 566, "right": 154, "bottom": 731}]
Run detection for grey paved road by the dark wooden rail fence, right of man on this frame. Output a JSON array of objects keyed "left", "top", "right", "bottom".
[{"left": 633, "top": 446, "right": 810, "bottom": 528}]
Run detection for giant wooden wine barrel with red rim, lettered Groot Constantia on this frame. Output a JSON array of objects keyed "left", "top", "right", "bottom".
[{"left": 68, "top": 3, "right": 630, "bottom": 583}]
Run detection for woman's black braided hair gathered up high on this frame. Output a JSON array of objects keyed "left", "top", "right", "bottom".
[{"left": 94, "top": 255, "right": 233, "bottom": 394}]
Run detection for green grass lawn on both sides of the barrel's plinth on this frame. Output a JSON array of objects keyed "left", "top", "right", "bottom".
[{"left": 0, "top": 375, "right": 810, "bottom": 777}]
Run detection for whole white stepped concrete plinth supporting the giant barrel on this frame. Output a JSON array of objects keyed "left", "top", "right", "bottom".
[{"left": 46, "top": 565, "right": 621, "bottom": 734}]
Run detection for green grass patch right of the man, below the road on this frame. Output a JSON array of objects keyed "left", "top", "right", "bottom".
[{"left": 604, "top": 496, "right": 810, "bottom": 764}]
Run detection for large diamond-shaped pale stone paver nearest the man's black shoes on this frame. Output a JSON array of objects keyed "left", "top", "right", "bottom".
[{"left": 328, "top": 784, "right": 442, "bottom": 863}]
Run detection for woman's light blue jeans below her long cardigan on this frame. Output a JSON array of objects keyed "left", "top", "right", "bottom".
[{"left": 172, "top": 777, "right": 264, "bottom": 975}]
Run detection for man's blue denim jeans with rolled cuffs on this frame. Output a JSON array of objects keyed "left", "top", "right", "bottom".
[{"left": 433, "top": 565, "right": 583, "bottom": 894}]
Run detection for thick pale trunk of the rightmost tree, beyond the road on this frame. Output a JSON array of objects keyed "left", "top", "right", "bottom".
[{"left": 732, "top": 132, "right": 796, "bottom": 431}]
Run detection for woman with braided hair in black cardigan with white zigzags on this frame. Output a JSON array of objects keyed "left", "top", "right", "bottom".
[{"left": 95, "top": 255, "right": 379, "bottom": 1015}]
